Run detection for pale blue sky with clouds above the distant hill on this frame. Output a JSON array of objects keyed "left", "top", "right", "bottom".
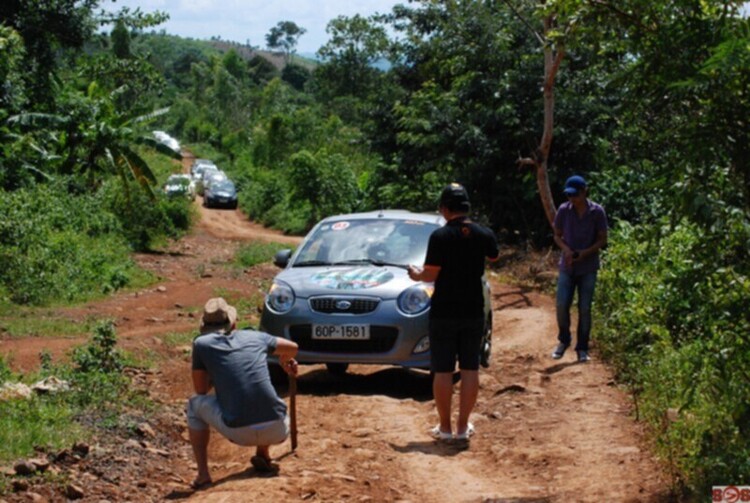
[{"left": 101, "top": 0, "right": 408, "bottom": 53}]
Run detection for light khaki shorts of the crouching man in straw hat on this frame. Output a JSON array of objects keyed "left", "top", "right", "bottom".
[{"left": 186, "top": 395, "right": 289, "bottom": 446}]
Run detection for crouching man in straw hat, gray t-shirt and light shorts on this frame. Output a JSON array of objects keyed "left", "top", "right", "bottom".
[{"left": 187, "top": 297, "right": 297, "bottom": 489}]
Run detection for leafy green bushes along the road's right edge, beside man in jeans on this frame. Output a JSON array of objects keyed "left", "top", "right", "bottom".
[{"left": 597, "top": 218, "right": 750, "bottom": 491}]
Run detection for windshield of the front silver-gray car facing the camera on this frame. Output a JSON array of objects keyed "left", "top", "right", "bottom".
[{"left": 293, "top": 218, "right": 438, "bottom": 267}]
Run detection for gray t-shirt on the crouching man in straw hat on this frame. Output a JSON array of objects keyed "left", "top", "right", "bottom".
[{"left": 193, "top": 330, "right": 286, "bottom": 428}]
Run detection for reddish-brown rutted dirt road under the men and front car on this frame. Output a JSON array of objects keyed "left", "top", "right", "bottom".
[{"left": 0, "top": 157, "right": 668, "bottom": 502}]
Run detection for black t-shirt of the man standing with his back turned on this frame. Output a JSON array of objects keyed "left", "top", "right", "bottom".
[{"left": 425, "top": 217, "right": 499, "bottom": 318}]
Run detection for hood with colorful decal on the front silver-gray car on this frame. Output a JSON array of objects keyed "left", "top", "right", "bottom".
[{"left": 276, "top": 265, "right": 415, "bottom": 298}]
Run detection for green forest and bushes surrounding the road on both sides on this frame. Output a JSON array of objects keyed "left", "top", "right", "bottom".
[{"left": 0, "top": 0, "right": 750, "bottom": 496}]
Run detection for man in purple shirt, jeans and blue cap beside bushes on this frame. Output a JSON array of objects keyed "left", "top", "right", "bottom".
[{"left": 552, "top": 175, "right": 607, "bottom": 363}]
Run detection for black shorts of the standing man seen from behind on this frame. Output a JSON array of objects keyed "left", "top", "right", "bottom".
[{"left": 430, "top": 318, "right": 484, "bottom": 372}]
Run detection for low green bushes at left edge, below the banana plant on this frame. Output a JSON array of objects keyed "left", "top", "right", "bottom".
[{"left": 0, "top": 184, "right": 151, "bottom": 304}]
